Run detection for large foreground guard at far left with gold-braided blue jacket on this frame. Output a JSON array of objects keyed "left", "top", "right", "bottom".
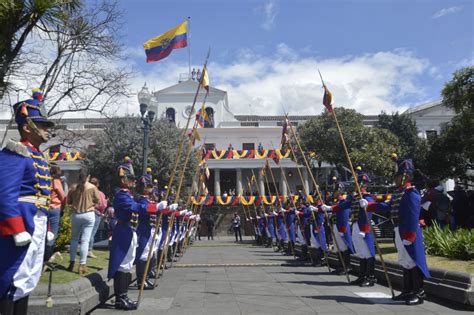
[{"left": 0, "top": 90, "right": 54, "bottom": 315}]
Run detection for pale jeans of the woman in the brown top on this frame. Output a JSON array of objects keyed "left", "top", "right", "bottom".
[{"left": 69, "top": 211, "right": 95, "bottom": 265}]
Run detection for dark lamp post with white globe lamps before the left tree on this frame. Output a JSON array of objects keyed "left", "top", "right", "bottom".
[{"left": 138, "top": 83, "right": 156, "bottom": 175}]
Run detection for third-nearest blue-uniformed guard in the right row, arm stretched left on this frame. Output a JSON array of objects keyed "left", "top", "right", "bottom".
[{"left": 322, "top": 184, "right": 355, "bottom": 274}]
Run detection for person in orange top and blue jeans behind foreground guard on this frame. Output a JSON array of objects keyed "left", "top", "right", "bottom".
[{"left": 44, "top": 163, "right": 66, "bottom": 261}]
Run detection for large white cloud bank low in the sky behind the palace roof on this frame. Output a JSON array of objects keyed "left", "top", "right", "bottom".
[{"left": 122, "top": 43, "right": 438, "bottom": 115}]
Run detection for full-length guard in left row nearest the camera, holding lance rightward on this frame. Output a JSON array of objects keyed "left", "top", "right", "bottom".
[{"left": 108, "top": 159, "right": 156, "bottom": 310}]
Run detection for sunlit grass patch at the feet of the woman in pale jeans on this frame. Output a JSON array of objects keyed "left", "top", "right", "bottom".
[{"left": 40, "top": 249, "right": 109, "bottom": 284}]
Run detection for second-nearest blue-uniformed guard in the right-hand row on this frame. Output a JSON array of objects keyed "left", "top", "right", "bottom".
[{"left": 350, "top": 166, "right": 376, "bottom": 287}]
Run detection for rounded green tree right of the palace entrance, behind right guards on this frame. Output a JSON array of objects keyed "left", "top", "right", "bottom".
[{"left": 299, "top": 108, "right": 399, "bottom": 181}]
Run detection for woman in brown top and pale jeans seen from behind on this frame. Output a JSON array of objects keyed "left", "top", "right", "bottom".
[{"left": 67, "top": 168, "right": 100, "bottom": 275}]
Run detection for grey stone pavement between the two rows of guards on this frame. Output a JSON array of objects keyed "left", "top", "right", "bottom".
[{"left": 93, "top": 237, "right": 472, "bottom": 315}]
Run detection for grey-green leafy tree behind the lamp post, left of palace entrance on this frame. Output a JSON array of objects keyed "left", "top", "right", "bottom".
[{"left": 85, "top": 116, "right": 197, "bottom": 197}]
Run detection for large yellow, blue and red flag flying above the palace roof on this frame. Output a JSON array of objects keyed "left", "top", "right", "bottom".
[{"left": 143, "top": 21, "right": 188, "bottom": 62}]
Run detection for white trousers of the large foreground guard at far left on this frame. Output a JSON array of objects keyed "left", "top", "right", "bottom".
[{"left": 12, "top": 211, "right": 48, "bottom": 301}]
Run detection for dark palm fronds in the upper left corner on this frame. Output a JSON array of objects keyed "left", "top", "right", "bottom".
[{"left": 0, "top": 0, "right": 82, "bottom": 99}]
